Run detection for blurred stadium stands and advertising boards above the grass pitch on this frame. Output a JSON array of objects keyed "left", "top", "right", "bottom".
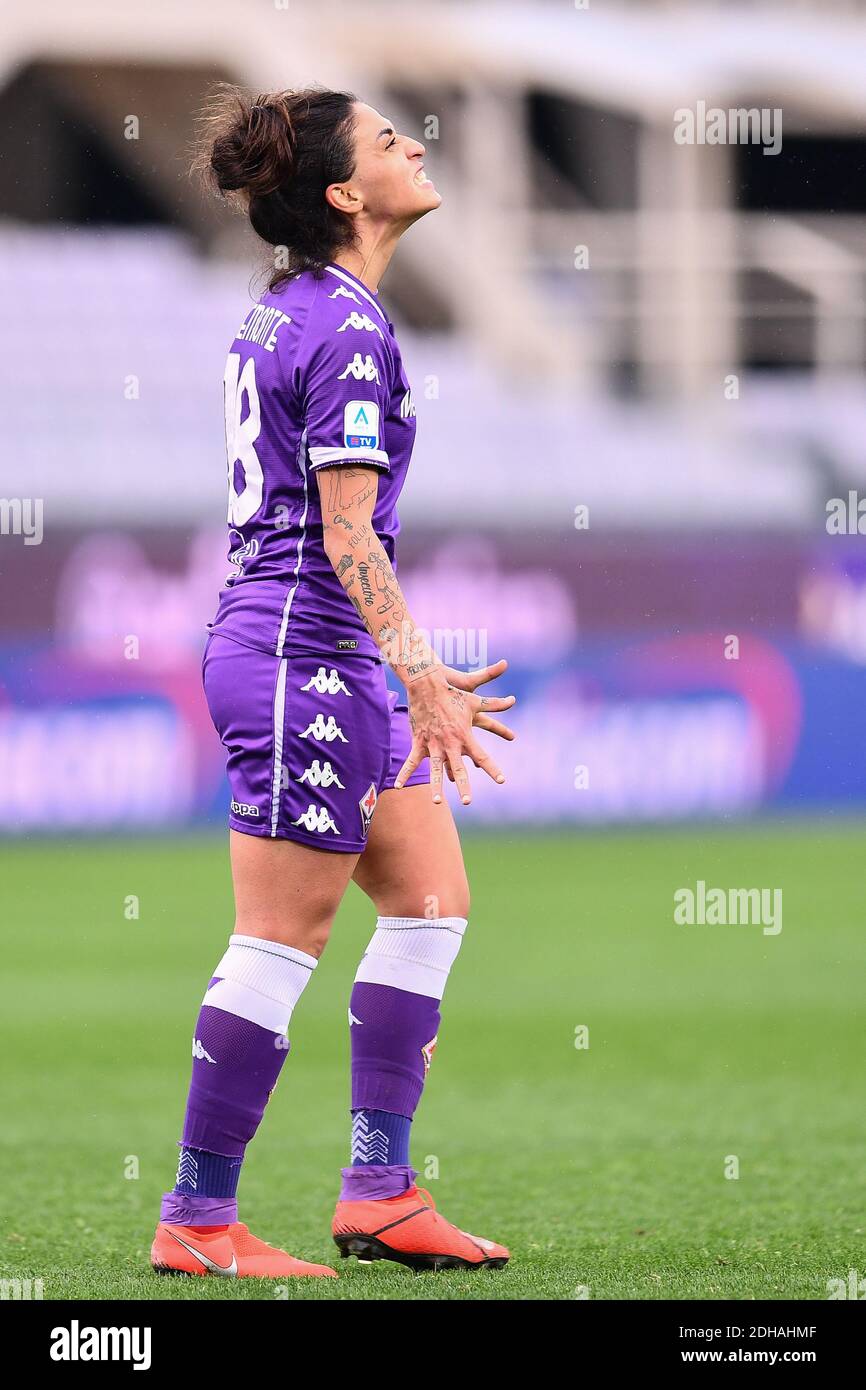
[{"left": 0, "top": 0, "right": 866, "bottom": 834}]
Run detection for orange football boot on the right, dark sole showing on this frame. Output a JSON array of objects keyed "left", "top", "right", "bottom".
[{"left": 332, "top": 1187, "right": 509, "bottom": 1270}]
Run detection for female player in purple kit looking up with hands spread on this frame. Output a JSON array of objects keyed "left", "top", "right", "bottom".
[{"left": 152, "top": 90, "right": 513, "bottom": 1279}]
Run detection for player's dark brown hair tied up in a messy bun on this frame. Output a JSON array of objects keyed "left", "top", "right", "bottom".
[{"left": 193, "top": 83, "right": 357, "bottom": 289}]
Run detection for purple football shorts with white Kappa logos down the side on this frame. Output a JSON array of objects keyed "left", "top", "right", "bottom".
[{"left": 202, "top": 632, "right": 430, "bottom": 855}]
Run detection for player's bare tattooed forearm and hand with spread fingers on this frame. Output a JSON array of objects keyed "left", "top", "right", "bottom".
[{"left": 317, "top": 467, "right": 514, "bottom": 805}]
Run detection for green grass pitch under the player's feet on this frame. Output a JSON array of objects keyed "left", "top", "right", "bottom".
[{"left": 0, "top": 821, "right": 866, "bottom": 1300}]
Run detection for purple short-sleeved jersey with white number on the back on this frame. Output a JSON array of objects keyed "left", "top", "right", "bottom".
[{"left": 210, "top": 265, "right": 416, "bottom": 656}]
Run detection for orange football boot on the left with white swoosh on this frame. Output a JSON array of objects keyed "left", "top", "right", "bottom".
[{"left": 150, "top": 1220, "right": 336, "bottom": 1279}]
